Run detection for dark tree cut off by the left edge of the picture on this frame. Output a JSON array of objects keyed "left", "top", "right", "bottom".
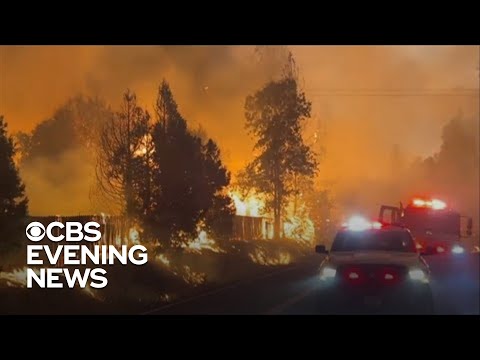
[{"left": 0, "top": 116, "right": 28, "bottom": 246}]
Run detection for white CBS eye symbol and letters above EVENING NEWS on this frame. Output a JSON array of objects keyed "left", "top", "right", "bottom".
[{"left": 25, "top": 221, "right": 102, "bottom": 242}]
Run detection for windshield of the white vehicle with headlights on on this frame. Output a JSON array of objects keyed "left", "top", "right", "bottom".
[{"left": 331, "top": 231, "right": 416, "bottom": 252}]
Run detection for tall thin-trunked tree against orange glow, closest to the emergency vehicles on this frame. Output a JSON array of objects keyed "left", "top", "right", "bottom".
[{"left": 241, "top": 73, "right": 317, "bottom": 239}]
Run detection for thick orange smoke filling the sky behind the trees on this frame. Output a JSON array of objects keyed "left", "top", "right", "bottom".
[{"left": 0, "top": 46, "right": 479, "bottom": 219}]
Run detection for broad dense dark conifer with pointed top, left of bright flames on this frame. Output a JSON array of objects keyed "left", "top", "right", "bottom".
[{"left": 147, "top": 81, "right": 232, "bottom": 245}]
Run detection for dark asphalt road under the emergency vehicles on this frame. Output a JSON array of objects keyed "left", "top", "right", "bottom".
[{"left": 148, "top": 253, "right": 480, "bottom": 315}]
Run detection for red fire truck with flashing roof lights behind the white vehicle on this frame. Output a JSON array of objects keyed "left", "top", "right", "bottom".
[{"left": 379, "top": 198, "right": 472, "bottom": 255}]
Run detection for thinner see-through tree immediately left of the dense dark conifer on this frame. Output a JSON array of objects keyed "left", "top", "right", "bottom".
[{"left": 96, "top": 90, "right": 150, "bottom": 216}]
